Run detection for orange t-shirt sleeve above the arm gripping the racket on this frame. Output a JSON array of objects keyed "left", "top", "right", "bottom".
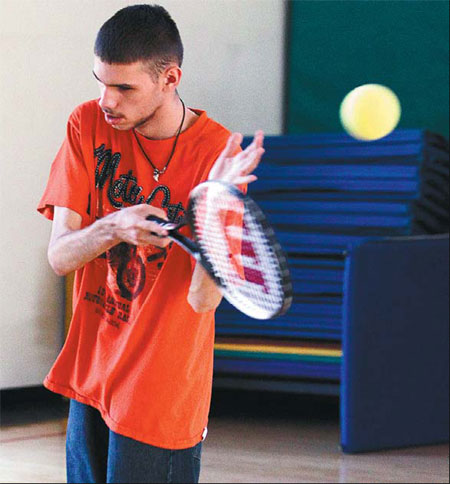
[{"left": 37, "top": 108, "right": 90, "bottom": 225}]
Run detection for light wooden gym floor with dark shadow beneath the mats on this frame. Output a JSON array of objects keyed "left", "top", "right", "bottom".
[{"left": 0, "top": 390, "right": 449, "bottom": 483}]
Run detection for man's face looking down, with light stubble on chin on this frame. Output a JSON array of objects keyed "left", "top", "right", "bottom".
[{"left": 93, "top": 57, "right": 164, "bottom": 130}]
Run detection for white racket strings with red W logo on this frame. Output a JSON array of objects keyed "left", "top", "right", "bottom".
[{"left": 192, "top": 184, "right": 285, "bottom": 319}]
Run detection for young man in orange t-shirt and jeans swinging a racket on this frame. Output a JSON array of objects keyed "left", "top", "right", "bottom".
[{"left": 38, "top": 5, "right": 264, "bottom": 482}]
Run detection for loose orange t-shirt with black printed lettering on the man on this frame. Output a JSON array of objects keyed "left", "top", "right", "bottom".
[{"left": 38, "top": 100, "right": 230, "bottom": 449}]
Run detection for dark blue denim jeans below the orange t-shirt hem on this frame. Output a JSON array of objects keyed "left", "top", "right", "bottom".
[{"left": 66, "top": 400, "right": 202, "bottom": 483}]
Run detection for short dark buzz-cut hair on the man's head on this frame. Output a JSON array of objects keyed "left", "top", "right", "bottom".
[{"left": 94, "top": 4, "right": 183, "bottom": 75}]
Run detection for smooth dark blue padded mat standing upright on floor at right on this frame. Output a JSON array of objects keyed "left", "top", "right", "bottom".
[{"left": 341, "top": 235, "right": 449, "bottom": 452}]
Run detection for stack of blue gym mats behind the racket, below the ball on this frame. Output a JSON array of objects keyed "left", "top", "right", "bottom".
[{"left": 215, "top": 130, "right": 449, "bottom": 386}]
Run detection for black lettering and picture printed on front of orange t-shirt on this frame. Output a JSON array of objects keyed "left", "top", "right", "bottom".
[{"left": 85, "top": 144, "right": 185, "bottom": 327}]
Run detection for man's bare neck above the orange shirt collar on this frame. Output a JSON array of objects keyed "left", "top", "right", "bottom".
[{"left": 136, "top": 96, "right": 198, "bottom": 140}]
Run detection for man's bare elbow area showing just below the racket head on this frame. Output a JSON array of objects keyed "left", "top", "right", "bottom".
[{"left": 188, "top": 263, "right": 222, "bottom": 313}]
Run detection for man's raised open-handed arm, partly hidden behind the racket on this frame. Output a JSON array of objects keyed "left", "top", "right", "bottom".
[{"left": 188, "top": 131, "right": 264, "bottom": 313}]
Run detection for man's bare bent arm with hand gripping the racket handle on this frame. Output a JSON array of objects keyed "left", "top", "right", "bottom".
[{"left": 48, "top": 204, "right": 170, "bottom": 276}]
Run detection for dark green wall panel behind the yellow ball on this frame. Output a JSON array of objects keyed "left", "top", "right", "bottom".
[{"left": 286, "top": 0, "right": 449, "bottom": 137}]
